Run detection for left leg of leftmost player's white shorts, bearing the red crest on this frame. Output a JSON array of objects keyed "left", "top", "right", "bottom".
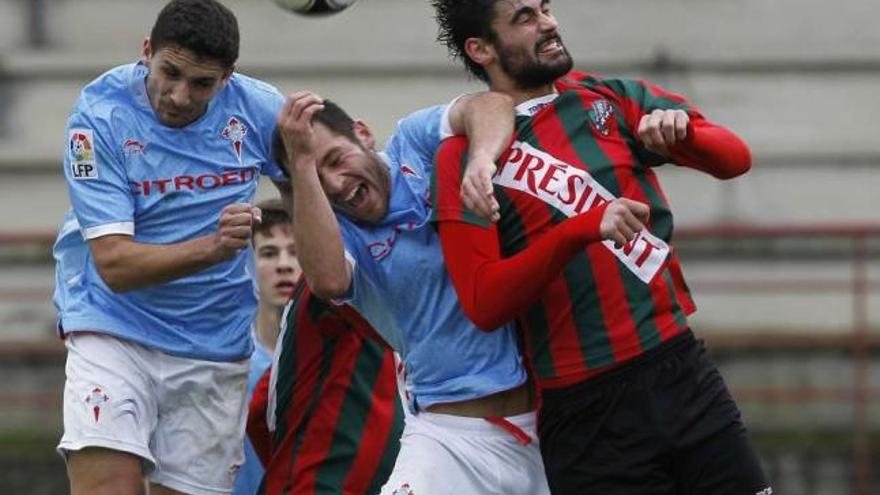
[{"left": 58, "top": 333, "right": 157, "bottom": 469}]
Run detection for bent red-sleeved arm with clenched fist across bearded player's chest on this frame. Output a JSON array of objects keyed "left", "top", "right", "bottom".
[{"left": 436, "top": 138, "right": 648, "bottom": 331}]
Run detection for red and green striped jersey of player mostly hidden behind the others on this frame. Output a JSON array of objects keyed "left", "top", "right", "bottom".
[{"left": 260, "top": 282, "right": 404, "bottom": 495}]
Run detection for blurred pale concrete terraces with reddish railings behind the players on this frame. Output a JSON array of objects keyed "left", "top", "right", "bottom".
[{"left": 0, "top": 0, "right": 880, "bottom": 495}]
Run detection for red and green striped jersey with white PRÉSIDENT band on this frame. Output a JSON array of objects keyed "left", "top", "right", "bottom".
[{"left": 433, "top": 73, "right": 703, "bottom": 387}]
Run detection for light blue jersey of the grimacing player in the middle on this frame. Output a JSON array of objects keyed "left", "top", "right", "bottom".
[{"left": 337, "top": 106, "right": 526, "bottom": 412}]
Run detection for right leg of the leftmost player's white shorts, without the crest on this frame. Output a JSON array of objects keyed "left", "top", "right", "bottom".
[{"left": 150, "top": 355, "right": 248, "bottom": 495}]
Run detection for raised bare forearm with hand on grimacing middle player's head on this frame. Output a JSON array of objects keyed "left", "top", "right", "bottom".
[{"left": 278, "top": 92, "right": 352, "bottom": 299}]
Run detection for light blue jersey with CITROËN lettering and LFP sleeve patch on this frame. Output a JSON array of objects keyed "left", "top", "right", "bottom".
[{"left": 54, "top": 64, "right": 284, "bottom": 361}]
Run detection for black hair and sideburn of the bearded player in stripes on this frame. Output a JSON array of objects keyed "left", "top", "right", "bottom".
[{"left": 431, "top": 0, "right": 498, "bottom": 83}]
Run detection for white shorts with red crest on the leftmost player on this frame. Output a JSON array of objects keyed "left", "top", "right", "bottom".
[{"left": 58, "top": 332, "right": 248, "bottom": 495}]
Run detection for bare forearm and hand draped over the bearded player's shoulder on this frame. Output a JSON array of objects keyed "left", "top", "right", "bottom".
[{"left": 449, "top": 91, "right": 514, "bottom": 221}]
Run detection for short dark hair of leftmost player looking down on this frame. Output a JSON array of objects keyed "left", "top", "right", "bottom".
[{"left": 150, "top": 0, "right": 239, "bottom": 68}]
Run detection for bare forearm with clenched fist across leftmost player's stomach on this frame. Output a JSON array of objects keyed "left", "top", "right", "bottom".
[{"left": 89, "top": 203, "right": 259, "bottom": 292}]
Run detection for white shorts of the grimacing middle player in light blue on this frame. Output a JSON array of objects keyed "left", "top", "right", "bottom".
[{"left": 381, "top": 412, "right": 550, "bottom": 495}]
